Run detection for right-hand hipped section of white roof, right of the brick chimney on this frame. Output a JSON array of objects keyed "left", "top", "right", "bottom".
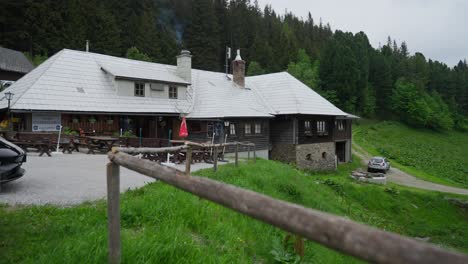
[{"left": 246, "top": 72, "right": 347, "bottom": 116}]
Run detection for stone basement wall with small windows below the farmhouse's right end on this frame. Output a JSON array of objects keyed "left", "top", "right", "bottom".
[{"left": 296, "top": 142, "right": 336, "bottom": 170}]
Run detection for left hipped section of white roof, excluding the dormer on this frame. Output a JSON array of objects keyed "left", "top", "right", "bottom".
[{"left": 0, "top": 50, "right": 189, "bottom": 113}]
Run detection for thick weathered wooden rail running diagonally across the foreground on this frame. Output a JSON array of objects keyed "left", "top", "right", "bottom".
[{"left": 109, "top": 152, "right": 468, "bottom": 264}]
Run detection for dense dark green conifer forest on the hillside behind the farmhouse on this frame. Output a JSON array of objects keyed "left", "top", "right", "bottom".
[{"left": 0, "top": 0, "right": 468, "bottom": 130}]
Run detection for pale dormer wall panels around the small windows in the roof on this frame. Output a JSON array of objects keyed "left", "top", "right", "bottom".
[{"left": 114, "top": 80, "right": 187, "bottom": 100}]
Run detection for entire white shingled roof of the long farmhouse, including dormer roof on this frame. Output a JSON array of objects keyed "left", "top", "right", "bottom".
[{"left": 0, "top": 49, "right": 348, "bottom": 118}]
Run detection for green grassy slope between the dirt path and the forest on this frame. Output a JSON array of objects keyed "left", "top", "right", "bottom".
[{"left": 353, "top": 121, "right": 468, "bottom": 188}]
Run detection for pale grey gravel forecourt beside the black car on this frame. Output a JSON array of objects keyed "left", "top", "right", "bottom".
[{"left": 0, "top": 153, "right": 154, "bottom": 206}]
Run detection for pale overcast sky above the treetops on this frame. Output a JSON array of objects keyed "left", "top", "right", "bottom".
[{"left": 258, "top": 0, "right": 468, "bottom": 66}]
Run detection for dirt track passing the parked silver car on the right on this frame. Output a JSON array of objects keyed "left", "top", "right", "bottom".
[{"left": 353, "top": 144, "right": 468, "bottom": 195}]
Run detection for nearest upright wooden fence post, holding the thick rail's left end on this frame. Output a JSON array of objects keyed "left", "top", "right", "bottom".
[{"left": 107, "top": 162, "right": 120, "bottom": 264}]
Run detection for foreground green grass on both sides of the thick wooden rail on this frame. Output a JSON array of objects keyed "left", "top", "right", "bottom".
[{"left": 0, "top": 159, "right": 468, "bottom": 263}]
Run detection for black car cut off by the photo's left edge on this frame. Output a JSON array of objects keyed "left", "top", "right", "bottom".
[{"left": 0, "top": 137, "right": 26, "bottom": 184}]
